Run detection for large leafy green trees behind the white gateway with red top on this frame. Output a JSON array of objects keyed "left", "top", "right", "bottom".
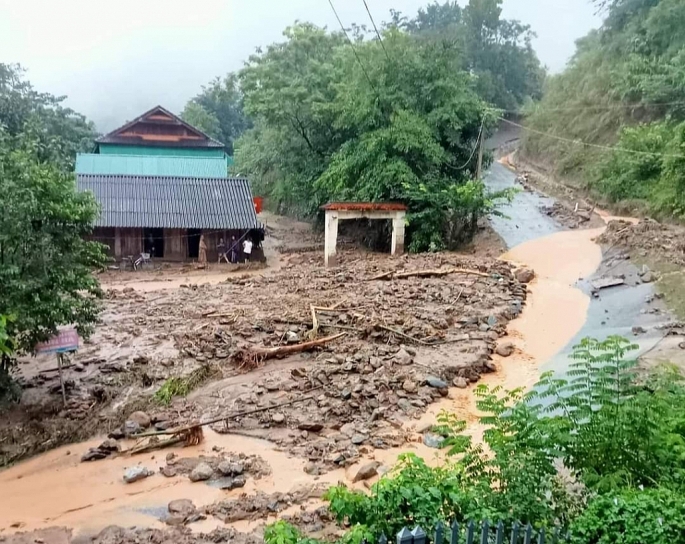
[{"left": 236, "top": 23, "right": 504, "bottom": 251}]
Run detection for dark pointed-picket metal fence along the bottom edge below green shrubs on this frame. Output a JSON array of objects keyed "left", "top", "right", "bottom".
[{"left": 378, "top": 521, "right": 568, "bottom": 544}]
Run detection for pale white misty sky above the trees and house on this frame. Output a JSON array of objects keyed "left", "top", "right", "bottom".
[{"left": 0, "top": 0, "right": 600, "bottom": 131}]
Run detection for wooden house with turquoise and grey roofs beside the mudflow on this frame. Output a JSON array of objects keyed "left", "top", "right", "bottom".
[{"left": 76, "top": 106, "right": 263, "bottom": 261}]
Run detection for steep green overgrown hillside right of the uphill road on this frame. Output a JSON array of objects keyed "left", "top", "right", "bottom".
[{"left": 522, "top": 0, "right": 685, "bottom": 219}]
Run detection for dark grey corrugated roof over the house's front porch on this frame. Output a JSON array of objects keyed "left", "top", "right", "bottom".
[{"left": 76, "top": 174, "right": 259, "bottom": 229}]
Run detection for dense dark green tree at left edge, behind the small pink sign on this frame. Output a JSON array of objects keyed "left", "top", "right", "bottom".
[{"left": 0, "top": 131, "right": 105, "bottom": 368}]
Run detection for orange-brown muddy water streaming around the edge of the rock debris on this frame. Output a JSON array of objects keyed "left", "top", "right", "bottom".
[{"left": 0, "top": 224, "right": 602, "bottom": 535}]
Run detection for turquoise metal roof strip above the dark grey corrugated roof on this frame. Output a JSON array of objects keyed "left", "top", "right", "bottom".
[{"left": 76, "top": 153, "right": 228, "bottom": 178}]
